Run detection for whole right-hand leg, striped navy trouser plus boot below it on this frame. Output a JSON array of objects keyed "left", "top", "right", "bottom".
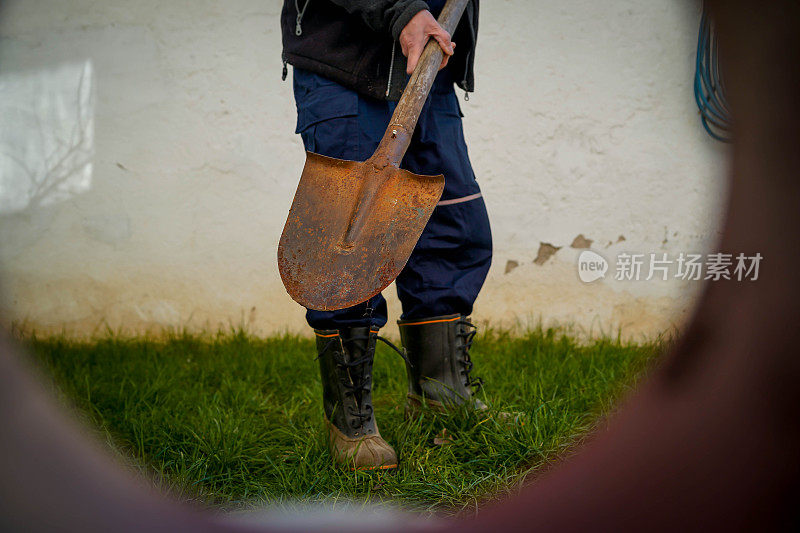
[{"left": 397, "top": 70, "right": 492, "bottom": 410}]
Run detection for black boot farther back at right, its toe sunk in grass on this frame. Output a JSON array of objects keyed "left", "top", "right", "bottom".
[{"left": 397, "top": 315, "right": 486, "bottom": 416}]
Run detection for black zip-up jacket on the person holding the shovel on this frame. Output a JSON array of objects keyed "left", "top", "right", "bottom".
[{"left": 281, "top": 0, "right": 478, "bottom": 100}]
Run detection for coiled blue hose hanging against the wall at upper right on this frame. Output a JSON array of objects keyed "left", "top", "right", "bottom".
[{"left": 694, "top": 12, "right": 732, "bottom": 142}]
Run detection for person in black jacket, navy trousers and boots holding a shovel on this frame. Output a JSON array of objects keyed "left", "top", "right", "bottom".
[{"left": 281, "top": 0, "right": 492, "bottom": 469}]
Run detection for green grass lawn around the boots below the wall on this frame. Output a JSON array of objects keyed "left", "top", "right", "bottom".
[{"left": 25, "top": 330, "right": 660, "bottom": 514}]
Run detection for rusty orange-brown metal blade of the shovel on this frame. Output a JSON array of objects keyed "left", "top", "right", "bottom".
[{"left": 278, "top": 152, "right": 444, "bottom": 311}]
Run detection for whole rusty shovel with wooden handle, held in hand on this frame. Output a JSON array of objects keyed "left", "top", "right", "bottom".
[{"left": 278, "top": 0, "right": 468, "bottom": 311}]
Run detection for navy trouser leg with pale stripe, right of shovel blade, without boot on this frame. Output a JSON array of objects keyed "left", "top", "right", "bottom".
[{"left": 397, "top": 71, "right": 492, "bottom": 321}]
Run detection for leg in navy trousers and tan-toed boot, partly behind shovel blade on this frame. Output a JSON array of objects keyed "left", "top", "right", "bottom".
[{"left": 294, "top": 69, "right": 397, "bottom": 469}]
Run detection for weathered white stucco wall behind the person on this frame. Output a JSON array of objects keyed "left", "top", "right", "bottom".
[{"left": 0, "top": 0, "right": 725, "bottom": 337}]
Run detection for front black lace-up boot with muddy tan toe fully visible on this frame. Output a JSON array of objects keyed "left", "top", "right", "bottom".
[{"left": 314, "top": 327, "right": 397, "bottom": 470}]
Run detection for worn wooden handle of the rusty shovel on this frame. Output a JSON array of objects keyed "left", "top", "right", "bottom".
[{"left": 375, "top": 0, "right": 469, "bottom": 167}]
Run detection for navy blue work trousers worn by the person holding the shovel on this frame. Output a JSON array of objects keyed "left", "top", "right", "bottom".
[{"left": 294, "top": 64, "right": 492, "bottom": 329}]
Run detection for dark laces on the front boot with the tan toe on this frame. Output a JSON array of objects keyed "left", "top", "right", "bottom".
[{"left": 317, "top": 335, "right": 411, "bottom": 429}]
